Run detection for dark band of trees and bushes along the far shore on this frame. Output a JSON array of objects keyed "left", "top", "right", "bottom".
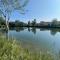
[{"left": 0, "top": 17, "right": 60, "bottom": 28}]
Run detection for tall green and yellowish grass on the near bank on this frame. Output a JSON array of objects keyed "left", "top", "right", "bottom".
[{"left": 0, "top": 38, "right": 54, "bottom": 60}]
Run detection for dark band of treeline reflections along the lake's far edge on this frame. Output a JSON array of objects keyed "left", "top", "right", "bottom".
[{"left": 7, "top": 27, "right": 60, "bottom": 36}]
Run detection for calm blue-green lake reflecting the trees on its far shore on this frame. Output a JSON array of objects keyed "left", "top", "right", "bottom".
[{"left": 1, "top": 27, "right": 60, "bottom": 59}]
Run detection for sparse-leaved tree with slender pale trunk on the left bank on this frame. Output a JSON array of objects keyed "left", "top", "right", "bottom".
[{"left": 0, "top": 0, "right": 28, "bottom": 29}]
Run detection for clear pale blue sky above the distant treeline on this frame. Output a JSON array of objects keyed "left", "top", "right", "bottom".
[{"left": 10, "top": 0, "right": 60, "bottom": 22}]
